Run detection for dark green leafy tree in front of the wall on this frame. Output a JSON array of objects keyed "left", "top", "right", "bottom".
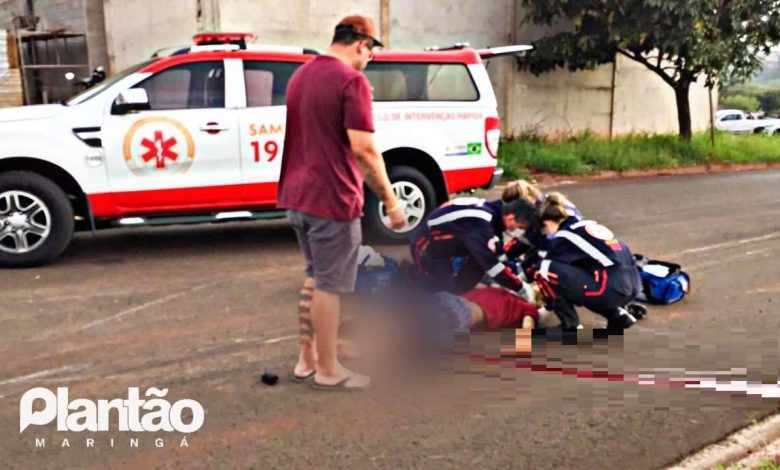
[{"left": 519, "top": 0, "right": 780, "bottom": 141}]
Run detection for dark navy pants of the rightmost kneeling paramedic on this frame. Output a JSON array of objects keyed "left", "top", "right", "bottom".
[{"left": 537, "top": 261, "right": 638, "bottom": 329}]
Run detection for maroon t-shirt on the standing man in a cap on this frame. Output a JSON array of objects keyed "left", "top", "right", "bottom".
[{"left": 278, "top": 55, "right": 374, "bottom": 221}]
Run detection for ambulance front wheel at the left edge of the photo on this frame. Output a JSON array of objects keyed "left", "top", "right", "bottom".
[{"left": 0, "top": 171, "right": 74, "bottom": 268}]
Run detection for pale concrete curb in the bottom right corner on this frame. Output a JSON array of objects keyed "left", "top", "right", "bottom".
[{"left": 667, "top": 414, "right": 780, "bottom": 470}]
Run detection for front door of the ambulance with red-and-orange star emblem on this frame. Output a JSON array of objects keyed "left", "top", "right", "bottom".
[{"left": 103, "top": 60, "right": 241, "bottom": 214}]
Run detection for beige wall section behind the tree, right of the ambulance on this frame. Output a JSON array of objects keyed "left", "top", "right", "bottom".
[{"left": 505, "top": 2, "right": 717, "bottom": 136}]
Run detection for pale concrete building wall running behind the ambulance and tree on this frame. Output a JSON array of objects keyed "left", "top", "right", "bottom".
[{"left": 99, "top": 0, "right": 720, "bottom": 135}]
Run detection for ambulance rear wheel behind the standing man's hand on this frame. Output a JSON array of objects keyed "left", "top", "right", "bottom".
[{"left": 363, "top": 166, "right": 436, "bottom": 245}]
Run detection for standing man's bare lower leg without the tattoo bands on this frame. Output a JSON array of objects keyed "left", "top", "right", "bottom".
[{"left": 311, "top": 289, "right": 369, "bottom": 388}]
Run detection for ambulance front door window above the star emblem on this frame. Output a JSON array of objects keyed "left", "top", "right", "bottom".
[{"left": 136, "top": 61, "right": 225, "bottom": 110}]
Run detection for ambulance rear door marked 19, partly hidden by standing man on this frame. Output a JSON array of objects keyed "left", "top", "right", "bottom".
[{"left": 238, "top": 60, "right": 302, "bottom": 208}]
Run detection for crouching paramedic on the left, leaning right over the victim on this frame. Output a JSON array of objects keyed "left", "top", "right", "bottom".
[{"left": 410, "top": 198, "right": 538, "bottom": 294}]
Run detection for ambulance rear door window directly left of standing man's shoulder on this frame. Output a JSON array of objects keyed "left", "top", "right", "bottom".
[{"left": 244, "top": 60, "right": 301, "bottom": 108}]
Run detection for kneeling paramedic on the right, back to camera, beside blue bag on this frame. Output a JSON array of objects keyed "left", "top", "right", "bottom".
[{"left": 535, "top": 197, "right": 639, "bottom": 332}]
